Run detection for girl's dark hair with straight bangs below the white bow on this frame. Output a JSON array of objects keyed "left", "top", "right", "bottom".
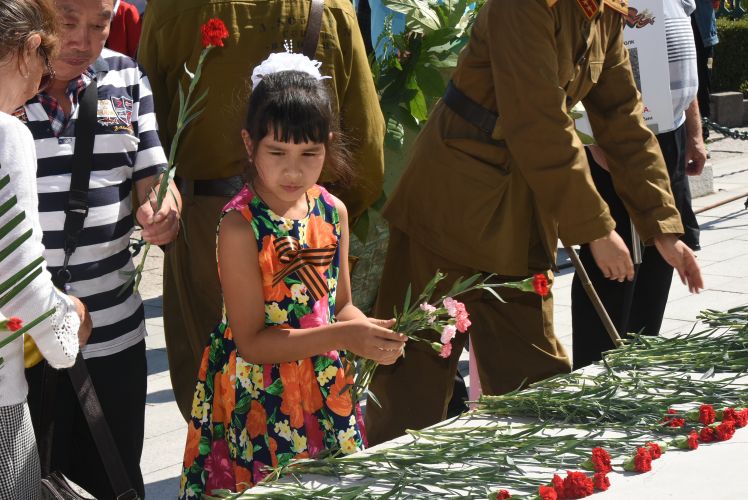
[{"left": 244, "top": 71, "right": 353, "bottom": 187}]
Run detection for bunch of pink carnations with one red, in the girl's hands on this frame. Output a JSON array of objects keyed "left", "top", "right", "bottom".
[{"left": 346, "top": 271, "right": 550, "bottom": 404}]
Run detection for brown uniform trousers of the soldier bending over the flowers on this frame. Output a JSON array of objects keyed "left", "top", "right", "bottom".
[{"left": 366, "top": 227, "right": 569, "bottom": 445}]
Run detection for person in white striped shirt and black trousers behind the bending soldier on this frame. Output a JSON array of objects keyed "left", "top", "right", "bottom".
[{"left": 571, "top": 0, "right": 706, "bottom": 369}]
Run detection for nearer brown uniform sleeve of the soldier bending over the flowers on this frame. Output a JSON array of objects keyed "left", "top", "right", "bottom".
[{"left": 482, "top": 0, "right": 615, "bottom": 245}]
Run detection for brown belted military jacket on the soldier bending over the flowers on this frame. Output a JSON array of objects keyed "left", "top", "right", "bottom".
[{"left": 385, "top": 0, "right": 683, "bottom": 275}]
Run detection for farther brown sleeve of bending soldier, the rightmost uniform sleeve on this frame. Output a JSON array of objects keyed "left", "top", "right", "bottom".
[{"left": 584, "top": 12, "right": 683, "bottom": 243}]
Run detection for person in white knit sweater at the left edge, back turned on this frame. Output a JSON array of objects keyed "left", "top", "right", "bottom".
[{"left": 0, "top": 0, "right": 91, "bottom": 500}]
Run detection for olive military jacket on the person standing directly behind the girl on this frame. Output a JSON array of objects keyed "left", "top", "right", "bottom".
[{"left": 138, "top": 0, "right": 384, "bottom": 216}]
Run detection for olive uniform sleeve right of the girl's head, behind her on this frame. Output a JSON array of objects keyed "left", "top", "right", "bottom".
[{"left": 336, "top": 5, "right": 384, "bottom": 219}]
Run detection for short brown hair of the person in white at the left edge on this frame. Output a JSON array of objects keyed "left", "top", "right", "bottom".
[{"left": 0, "top": 0, "right": 59, "bottom": 60}]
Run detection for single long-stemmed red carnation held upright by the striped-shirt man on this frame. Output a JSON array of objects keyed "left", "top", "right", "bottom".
[{"left": 119, "top": 18, "right": 229, "bottom": 294}]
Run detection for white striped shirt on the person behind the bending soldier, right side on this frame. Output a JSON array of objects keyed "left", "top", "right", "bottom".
[{"left": 660, "top": 0, "right": 699, "bottom": 132}]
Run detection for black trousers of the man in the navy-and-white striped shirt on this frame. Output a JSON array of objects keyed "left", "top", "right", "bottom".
[{"left": 26, "top": 340, "right": 147, "bottom": 500}]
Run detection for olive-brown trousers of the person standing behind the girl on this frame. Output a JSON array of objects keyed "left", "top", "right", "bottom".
[{"left": 163, "top": 196, "right": 230, "bottom": 421}]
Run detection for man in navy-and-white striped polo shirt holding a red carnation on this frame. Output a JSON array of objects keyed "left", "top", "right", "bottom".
[{"left": 21, "top": 0, "right": 181, "bottom": 499}]
